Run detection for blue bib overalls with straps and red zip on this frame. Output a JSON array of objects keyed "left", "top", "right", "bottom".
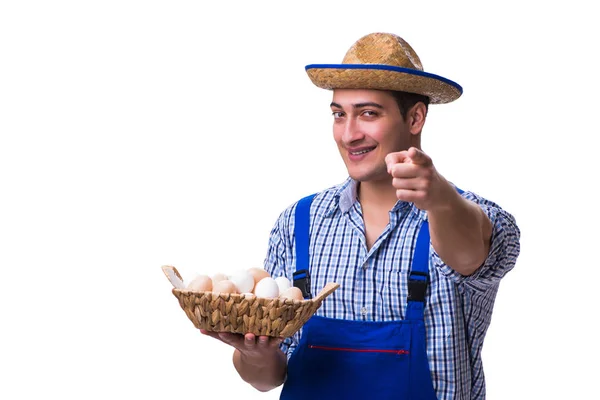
[{"left": 280, "top": 195, "right": 436, "bottom": 400}]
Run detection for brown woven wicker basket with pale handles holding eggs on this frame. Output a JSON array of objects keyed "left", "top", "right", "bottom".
[{"left": 162, "top": 265, "right": 340, "bottom": 337}]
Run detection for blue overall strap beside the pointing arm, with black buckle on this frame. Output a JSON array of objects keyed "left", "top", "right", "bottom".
[{"left": 406, "top": 188, "right": 464, "bottom": 320}]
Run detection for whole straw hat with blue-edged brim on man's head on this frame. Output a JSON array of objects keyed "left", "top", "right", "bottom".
[{"left": 306, "top": 33, "right": 462, "bottom": 104}]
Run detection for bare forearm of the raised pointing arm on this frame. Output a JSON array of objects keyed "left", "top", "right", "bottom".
[{"left": 428, "top": 191, "right": 492, "bottom": 276}]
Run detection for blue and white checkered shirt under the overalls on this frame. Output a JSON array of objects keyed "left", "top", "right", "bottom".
[{"left": 265, "top": 178, "right": 520, "bottom": 399}]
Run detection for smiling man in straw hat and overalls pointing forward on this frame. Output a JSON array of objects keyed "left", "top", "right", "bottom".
[{"left": 204, "top": 33, "right": 520, "bottom": 399}]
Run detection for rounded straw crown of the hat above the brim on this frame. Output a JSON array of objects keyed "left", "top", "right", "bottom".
[{"left": 342, "top": 33, "right": 423, "bottom": 71}]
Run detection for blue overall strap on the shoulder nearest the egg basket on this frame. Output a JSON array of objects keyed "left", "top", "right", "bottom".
[{"left": 294, "top": 193, "right": 316, "bottom": 299}]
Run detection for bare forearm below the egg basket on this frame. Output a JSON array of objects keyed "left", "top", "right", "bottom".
[{"left": 233, "top": 349, "right": 287, "bottom": 392}]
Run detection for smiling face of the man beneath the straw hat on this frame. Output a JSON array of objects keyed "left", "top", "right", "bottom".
[{"left": 331, "top": 89, "right": 413, "bottom": 182}]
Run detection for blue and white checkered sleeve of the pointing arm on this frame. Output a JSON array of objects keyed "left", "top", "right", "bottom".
[{"left": 432, "top": 192, "right": 521, "bottom": 291}]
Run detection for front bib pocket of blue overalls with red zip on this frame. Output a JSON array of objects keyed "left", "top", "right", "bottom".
[{"left": 282, "top": 317, "right": 413, "bottom": 400}]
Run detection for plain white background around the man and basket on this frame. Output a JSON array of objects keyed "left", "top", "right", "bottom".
[{"left": 0, "top": 0, "right": 600, "bottom": 400}]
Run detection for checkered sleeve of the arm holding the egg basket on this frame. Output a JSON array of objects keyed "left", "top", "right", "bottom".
[{"left": 265, "top": 215, "right": 300, "bottom": 361}]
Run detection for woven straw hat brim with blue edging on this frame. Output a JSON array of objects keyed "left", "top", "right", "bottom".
[{"left": 305, "top": 64, "right": 463, "bottom": 104}]
